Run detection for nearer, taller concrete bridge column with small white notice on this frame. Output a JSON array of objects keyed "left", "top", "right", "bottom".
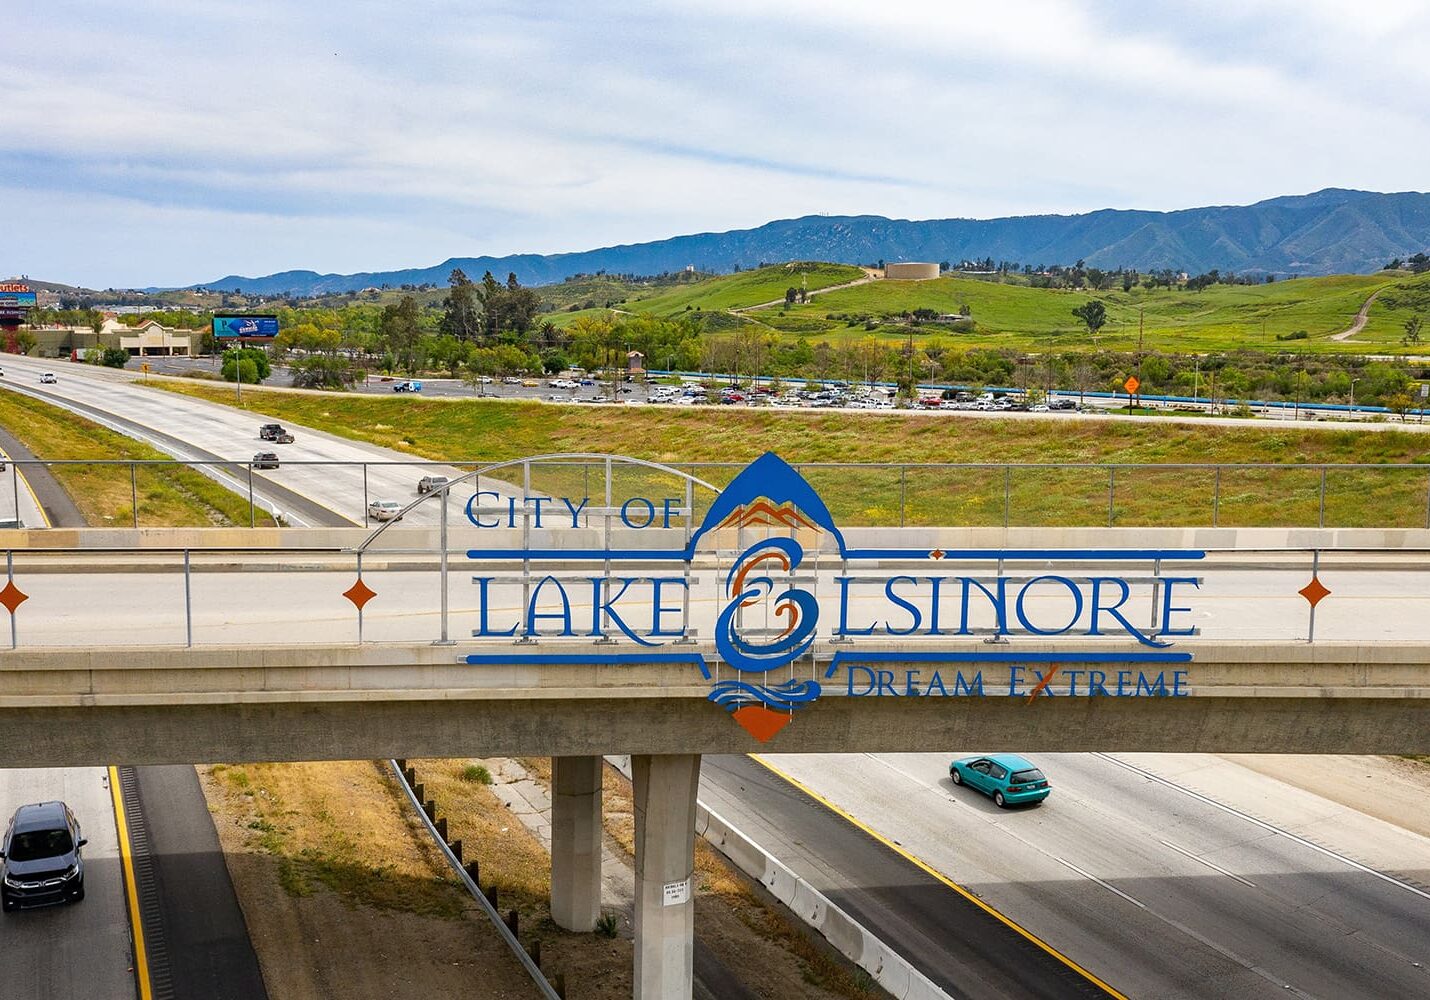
[{"left": 631, "top": 754, "right": 701, "bottom": 1000}]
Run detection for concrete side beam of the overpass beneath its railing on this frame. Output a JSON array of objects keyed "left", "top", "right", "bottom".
[{"left": 0, "top": 641, "right": 1430, "bottom": 767}]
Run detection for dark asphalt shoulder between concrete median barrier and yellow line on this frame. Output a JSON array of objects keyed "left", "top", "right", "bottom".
[{"left": 701, "top": 755, "right": 1108, "bottom": 1000}]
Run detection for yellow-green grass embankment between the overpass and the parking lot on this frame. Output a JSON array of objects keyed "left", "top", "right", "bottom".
[{"left": 164, "top": 382, "right": 1430, "bottom": 526}]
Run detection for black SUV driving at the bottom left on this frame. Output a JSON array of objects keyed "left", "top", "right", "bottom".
[{"left": 0, "top": 803, "right": 87, "bottom": 913}]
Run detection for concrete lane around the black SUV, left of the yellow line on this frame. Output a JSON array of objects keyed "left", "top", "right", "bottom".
[{"left": 0, "top": 767, "right": 136, "bottom": 1000}]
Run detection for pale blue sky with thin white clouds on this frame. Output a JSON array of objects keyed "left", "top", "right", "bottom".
[{"left": 0, "top": 0, "right": 1430, "bottom": 288}]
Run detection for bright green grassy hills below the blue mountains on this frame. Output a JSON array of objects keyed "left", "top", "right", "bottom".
[{"left": 531, "top": 263, "right": 1430, "bottom": 353}]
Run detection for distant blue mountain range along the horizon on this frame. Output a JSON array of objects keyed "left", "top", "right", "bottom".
[{"left": 193, "top": 187, "right": 1430, "bottom": 296}]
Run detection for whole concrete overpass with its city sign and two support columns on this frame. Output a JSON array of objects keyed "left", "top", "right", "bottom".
[{"left": 0, "top": 454, "right": 1430, "bottom": 997}]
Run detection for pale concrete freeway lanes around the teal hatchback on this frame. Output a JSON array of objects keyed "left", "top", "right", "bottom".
[{"left": 781, "top": 751, "right": 1426, "bottom": 997}]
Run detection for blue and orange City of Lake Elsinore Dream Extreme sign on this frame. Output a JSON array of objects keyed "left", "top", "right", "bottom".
[{"left": 465, "top": 452, "right": 1204, "bottom": 741}]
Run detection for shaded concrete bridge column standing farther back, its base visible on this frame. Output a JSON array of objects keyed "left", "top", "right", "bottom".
[{"left": 551, "top": 757, "right": 602, "bottom": 931}]
